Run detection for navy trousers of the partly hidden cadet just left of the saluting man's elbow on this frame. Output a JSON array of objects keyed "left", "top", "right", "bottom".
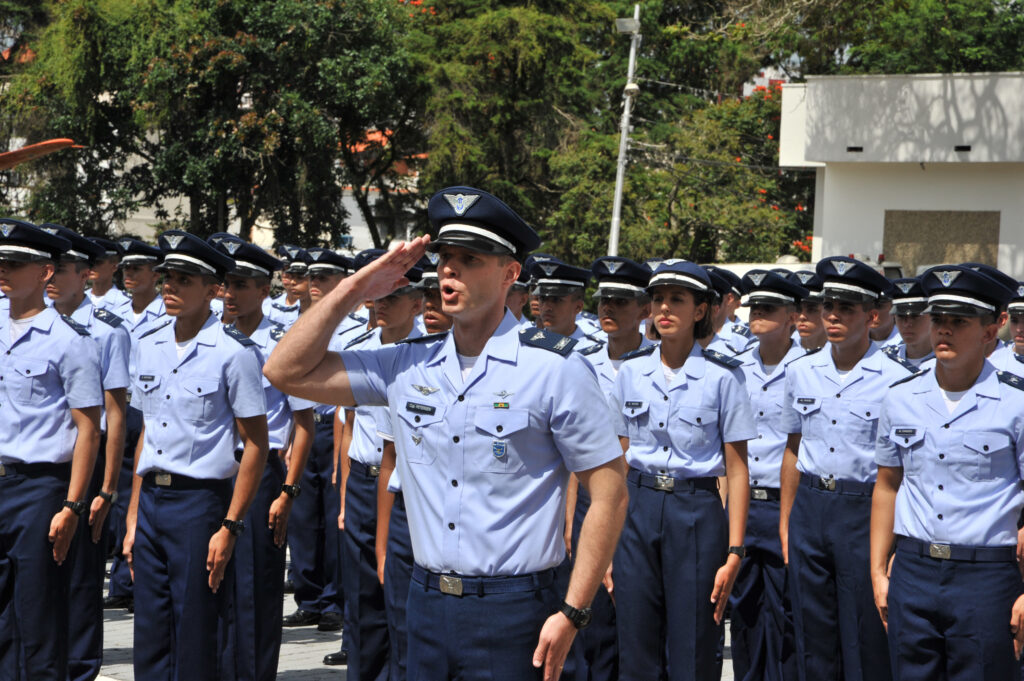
[{"left": 231, "top": 451, "right": 291, "bottom": 681}]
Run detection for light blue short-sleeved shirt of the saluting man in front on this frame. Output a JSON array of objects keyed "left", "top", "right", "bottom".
[{"left": 341, "top": 311, "right": 622, "bottom": 576}]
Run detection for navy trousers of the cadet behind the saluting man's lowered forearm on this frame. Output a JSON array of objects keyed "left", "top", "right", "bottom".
[{"left": 572, "top": 484, "right": 618, "bottom": 681}]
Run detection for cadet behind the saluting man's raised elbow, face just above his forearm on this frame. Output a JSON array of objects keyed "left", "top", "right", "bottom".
[{"left": 284, "top": 242, "right": 356, "bottom": 630}]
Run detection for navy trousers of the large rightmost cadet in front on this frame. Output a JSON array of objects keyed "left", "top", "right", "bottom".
[{"left": 889, "top": 549, "right": 1021, "bottom": 681}]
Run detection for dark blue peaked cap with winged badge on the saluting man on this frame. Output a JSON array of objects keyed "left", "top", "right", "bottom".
[{"left": 427, "top": 186, "right": 541, "bottom": 261}]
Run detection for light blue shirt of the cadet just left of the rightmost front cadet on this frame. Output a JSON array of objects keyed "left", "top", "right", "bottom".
[{"left": 782, "top": 343, "right": 912, "bottom": 482}]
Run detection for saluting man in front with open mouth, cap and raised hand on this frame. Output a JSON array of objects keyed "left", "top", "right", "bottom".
[{"left": 266, "top": 187, "right": 626, "bottom": 680}]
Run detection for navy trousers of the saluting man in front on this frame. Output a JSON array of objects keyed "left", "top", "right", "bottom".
[{"left": 407, "top": 573, "right": 575, "bottom": 681}]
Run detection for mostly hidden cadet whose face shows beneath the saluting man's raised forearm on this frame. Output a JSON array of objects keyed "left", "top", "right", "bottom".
[{"left": 341, "top": 251, "right": 423, "bottom": 681}]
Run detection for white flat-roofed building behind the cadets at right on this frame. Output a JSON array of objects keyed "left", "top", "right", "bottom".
[{"left": 779, "top": 73, "right": 1024, "bottom": 279}]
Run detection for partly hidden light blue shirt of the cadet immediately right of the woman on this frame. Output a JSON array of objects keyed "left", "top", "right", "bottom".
[{"left": 737, "top": 343, "right": 807, "bottom": 487}]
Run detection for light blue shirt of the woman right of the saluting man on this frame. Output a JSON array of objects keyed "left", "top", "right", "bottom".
[{"left": 614, "top": 343, "right": 758, "bottom": 478}]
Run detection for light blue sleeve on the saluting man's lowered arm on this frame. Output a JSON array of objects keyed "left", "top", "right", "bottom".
[{"left": 550, "top": 352, "right": 623, "bottom": 472}]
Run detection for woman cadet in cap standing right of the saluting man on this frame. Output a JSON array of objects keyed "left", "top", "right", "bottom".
[{"left": 612, "top": 260, "right": 757, "bottom": 681}]
